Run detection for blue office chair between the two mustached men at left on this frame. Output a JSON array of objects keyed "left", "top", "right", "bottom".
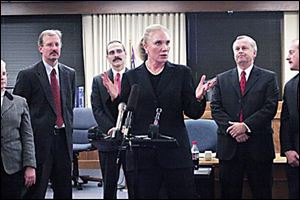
[{"left": 72, "top": 108, "right": 102, "bottom": 190}]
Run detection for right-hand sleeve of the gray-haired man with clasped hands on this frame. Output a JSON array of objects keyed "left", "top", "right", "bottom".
[{"left": 244, "top": 73, "right": 279, "bottom": 131}]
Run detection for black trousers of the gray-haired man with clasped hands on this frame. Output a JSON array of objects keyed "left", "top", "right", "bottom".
[{"left": 219, "top": 153, "right": 273, "bottom": 199}]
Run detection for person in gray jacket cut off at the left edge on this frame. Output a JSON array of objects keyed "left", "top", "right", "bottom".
[{"left": 1, "top": 60, "right": 36, "bottom": 199}]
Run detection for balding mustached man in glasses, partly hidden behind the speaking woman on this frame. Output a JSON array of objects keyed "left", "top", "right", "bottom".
[{"left": 91, "top": 40, "right": 131, "bottom": 199}]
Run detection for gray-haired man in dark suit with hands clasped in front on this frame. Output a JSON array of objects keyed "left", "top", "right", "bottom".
[{"left": 211, "top": 35, "right": 279, "bottom": 199}]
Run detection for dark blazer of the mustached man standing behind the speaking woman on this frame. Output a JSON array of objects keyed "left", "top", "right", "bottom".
[{"left": 91, "top": 68, "right": 128, "bottom": 151}]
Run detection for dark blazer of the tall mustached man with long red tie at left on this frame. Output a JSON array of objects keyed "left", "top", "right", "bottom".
[{"left": 13, "top": 61, "right": 76, "bottom": 163}]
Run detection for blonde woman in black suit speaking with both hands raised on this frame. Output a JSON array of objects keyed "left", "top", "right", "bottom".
[{"left": 103, "top": 24, "right": 213, "bottom": 199}]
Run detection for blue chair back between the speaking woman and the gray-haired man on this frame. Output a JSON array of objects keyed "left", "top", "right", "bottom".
[{"left": 184, "top": 119, "right": 218, "bottom": 152}]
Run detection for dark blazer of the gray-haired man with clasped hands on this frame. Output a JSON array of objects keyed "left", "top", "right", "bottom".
[{"left": 211, "top": 66, "right": 279, "bottom": 161}]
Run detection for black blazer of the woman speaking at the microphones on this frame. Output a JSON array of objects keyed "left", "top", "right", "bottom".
[{"left": 115, "top": 62, "right": 206, "bottom": 168}]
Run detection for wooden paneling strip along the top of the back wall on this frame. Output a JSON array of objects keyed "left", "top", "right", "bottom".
[{"left": 1, "top": 1, "right": 299, "bottom": 16}]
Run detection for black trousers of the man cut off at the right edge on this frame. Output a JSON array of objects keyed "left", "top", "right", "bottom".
[{"left": 286, "top": 164, "right": 299, "bottom": 199}]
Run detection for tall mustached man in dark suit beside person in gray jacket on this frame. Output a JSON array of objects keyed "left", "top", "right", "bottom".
[{"left": 14, "top": 30, "right": 76, "bottom": 199}]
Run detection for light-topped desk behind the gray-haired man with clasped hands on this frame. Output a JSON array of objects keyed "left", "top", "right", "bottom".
[{"left": 196, "top": 153, "right": 288, "bottom": 199}]
